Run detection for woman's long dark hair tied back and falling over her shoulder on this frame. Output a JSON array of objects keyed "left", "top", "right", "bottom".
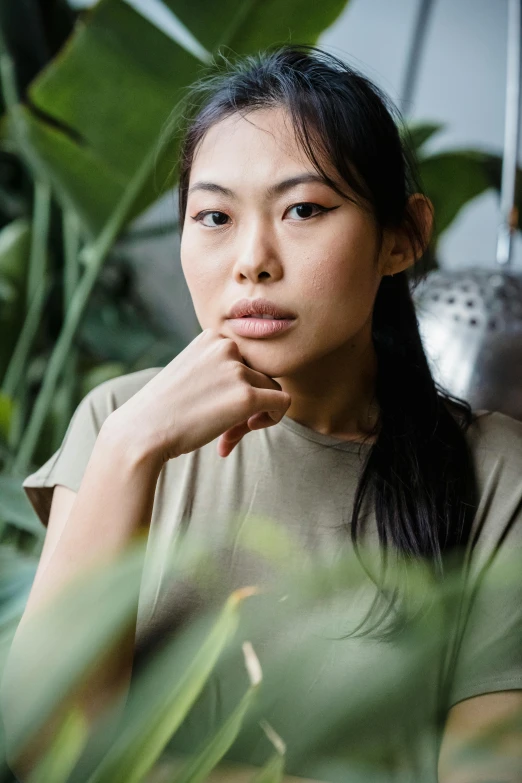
[{"left": 170, "top": 44, "right": 476, "bottom": 632}]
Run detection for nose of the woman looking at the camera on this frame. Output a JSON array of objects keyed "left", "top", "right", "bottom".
[{"left": 233, "top": 219, "right": 283, "bottom": 283}]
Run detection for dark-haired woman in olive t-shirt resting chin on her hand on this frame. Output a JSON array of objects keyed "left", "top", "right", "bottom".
[{"left": 12, "top": 46, "right": 522, "bottom": 783}]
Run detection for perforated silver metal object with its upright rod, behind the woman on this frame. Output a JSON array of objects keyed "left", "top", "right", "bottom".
[{"left": 414, "top": 0, "right": 522, "bottom": 420}]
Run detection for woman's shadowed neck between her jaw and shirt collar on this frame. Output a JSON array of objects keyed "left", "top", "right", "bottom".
[{"left": 275, "top": 324, "right": 379, "bottom": 442}]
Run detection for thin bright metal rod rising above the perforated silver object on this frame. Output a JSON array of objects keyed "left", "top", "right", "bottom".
[{"left": 497, "top": 0, "right": 522, "bottom": 266}]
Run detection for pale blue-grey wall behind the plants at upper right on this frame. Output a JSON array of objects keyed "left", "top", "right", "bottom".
[{"left": 319, "top": 0, "right": 522, "bottom": 269}]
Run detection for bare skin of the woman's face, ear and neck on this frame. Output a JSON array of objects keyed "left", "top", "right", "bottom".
[{"left": 181, "top": 108, "right": 431, "bottom": 456}]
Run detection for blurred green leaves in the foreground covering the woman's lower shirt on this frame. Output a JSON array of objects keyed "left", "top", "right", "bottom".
[{"left": 0, "top": 518, "right": 522, "bottom": 783}]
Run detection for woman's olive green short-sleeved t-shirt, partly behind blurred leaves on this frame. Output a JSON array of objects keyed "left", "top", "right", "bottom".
[{"left": 23, "top": 368, "right": 522, "bottom": 783}]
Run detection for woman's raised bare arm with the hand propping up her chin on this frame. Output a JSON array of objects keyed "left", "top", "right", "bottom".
[{"left": 2, "top": 329, "right": 290, "bottom": 775}]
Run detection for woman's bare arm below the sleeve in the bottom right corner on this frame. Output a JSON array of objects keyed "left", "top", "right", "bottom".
[{"left": 438, "top": 690, "right": 522, "bottom": 783}]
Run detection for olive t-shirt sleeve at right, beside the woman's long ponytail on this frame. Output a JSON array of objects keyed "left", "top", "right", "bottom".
[{"left": 442, "top": 414, "right": 522, "bottom": 707}]
